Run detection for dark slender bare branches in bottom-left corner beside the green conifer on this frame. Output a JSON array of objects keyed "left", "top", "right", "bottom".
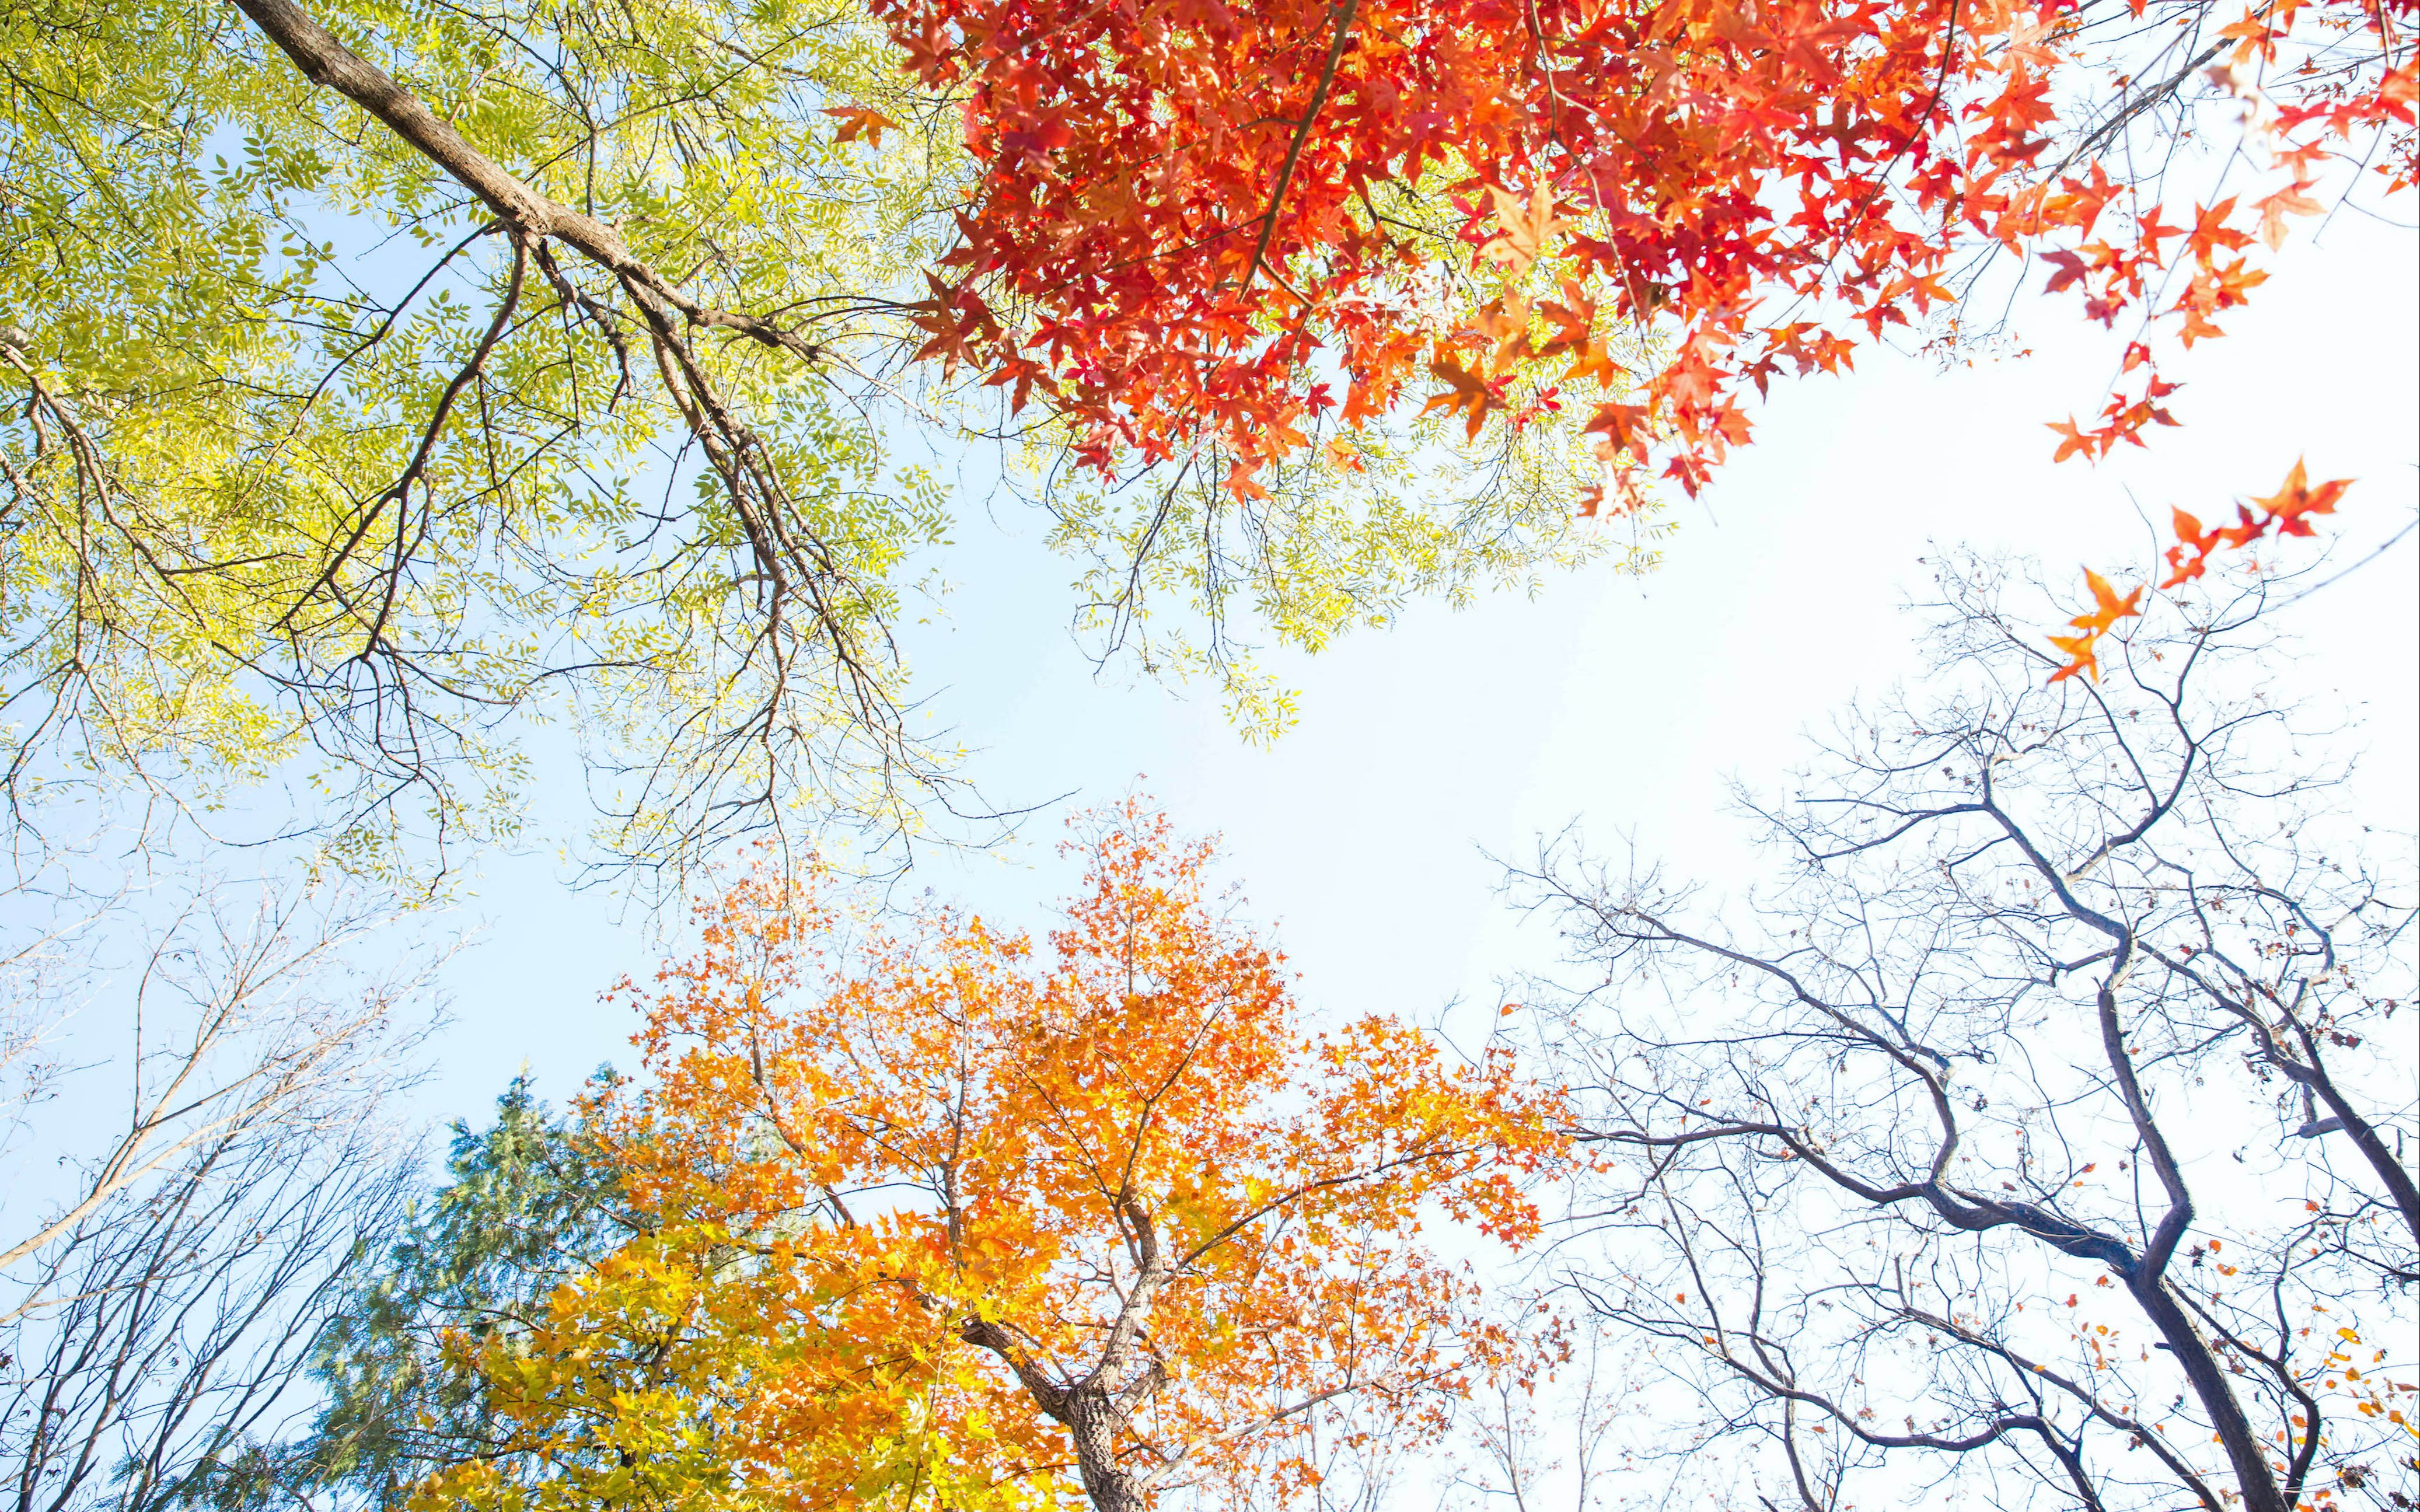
[{"left": 0, "top": 1120, "right": 409, "bottom": 1512}]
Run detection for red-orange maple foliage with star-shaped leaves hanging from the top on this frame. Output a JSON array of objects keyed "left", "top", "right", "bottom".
[{"left": 876, "top": 0, "right": 2415, "bottom": 529}]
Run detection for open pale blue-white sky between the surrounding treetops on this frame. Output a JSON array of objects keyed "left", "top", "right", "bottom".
[{"left": 424, "top": 191, "right": 2420, "bottom": 1118}]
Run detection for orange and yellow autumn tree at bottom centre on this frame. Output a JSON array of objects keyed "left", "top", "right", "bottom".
[{"left": 424, "top": 801, "right": 1551, "bottom": 1512}]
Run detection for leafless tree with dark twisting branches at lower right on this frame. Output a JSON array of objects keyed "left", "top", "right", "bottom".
[{"left": 1522, "top": 561, "right": 2420, "bottom": 1512}]
